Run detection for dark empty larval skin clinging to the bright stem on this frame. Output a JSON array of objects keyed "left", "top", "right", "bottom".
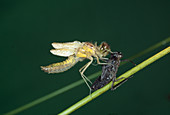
[{"left": 91, "top": 52, "right": 136, "bottom": 91}]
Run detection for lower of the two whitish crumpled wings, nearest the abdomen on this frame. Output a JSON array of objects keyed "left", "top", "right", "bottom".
[{"left": 50, "top": 48, "right": 75, "bottom": 57}]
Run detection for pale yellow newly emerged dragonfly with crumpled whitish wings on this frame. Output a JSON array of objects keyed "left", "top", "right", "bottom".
[{"left": 41, "top": 41, "right": 111, "bottom": 91}]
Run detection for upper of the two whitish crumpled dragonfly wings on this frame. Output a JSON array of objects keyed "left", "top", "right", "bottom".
[{"left": 52, "top": 41, "right": 82, "bottom": 49}]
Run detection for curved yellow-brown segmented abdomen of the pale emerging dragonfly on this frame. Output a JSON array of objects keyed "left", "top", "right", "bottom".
[{"left": 41, "top": 56, "right": 80, "bottom": 73}]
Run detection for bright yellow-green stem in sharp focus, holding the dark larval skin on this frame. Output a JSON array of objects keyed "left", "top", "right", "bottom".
[{"left": 59, "top": 47, "right": 170, "bottom": 115}]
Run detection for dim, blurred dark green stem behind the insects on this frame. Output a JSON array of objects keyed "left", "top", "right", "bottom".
[{"left": 5, "top": 37, "right": 170, "bottom": 115}]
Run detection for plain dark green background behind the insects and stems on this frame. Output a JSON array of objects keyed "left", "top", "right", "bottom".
[{"left": 0, "top": 0, "right": 170, "bottom": 115}]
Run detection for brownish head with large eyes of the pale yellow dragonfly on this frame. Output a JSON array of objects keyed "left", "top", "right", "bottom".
[{"left": 98, "top": 42, "right": 110, "bottom": 57}]
